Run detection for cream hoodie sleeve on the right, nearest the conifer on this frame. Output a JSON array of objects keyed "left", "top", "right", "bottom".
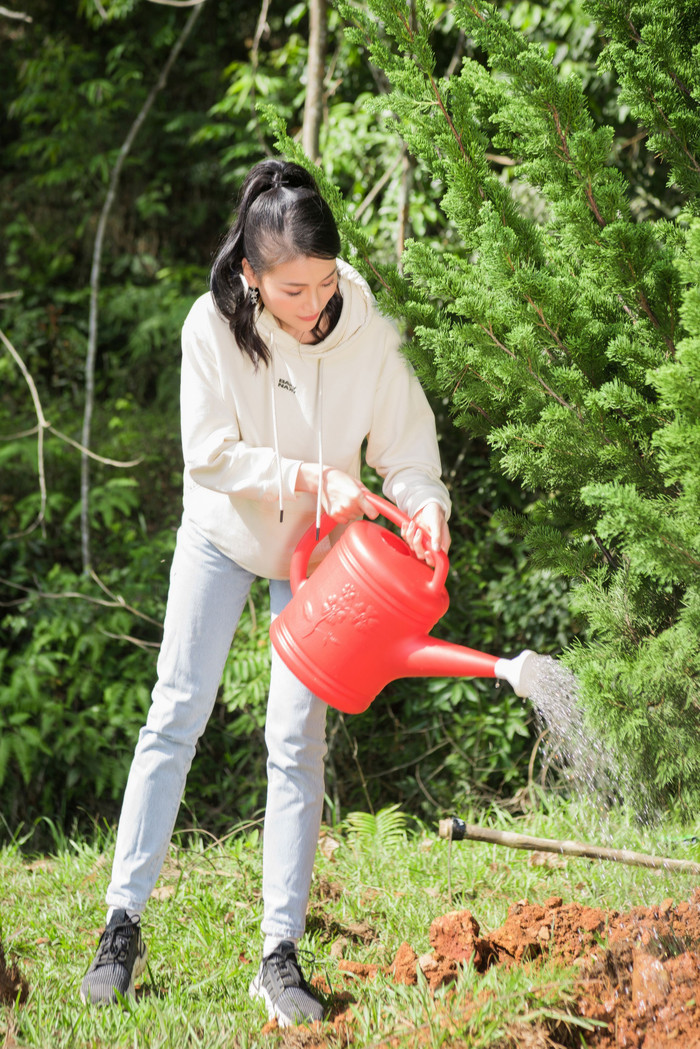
[{"left": 366, "top": 336, "right": 450, "bottom": 517}]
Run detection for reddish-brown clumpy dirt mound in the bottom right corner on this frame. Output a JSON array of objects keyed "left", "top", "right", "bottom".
[{"left": 310, "top": 890, "right": 700, "bottom": 1049}]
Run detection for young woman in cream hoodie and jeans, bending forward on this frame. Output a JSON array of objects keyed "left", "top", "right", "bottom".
[{"left": 81, "top": 160, "right": 449, "bottom": 1025}]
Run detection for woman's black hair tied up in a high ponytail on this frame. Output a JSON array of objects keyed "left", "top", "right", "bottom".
[{"left": 210, "top": 159, "right": 342, "bottom": 367}]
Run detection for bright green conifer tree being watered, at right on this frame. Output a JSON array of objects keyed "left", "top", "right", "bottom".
[{"left": 270, "top": 0, "right": 700, "bottom": 804}]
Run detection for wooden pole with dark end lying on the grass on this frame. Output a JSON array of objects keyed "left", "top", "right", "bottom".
[{"left": 439, "top": 817, "right": 700, "bottom": 874}]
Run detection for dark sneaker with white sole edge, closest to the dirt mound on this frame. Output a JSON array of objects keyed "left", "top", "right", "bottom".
[{"left": 249, "top": 940, "right": 323, "bottom": 1027}]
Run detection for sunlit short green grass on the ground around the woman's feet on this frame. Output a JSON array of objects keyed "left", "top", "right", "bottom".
[{"left": 0, "top": 799, "right": 697, "bottom": 1049}]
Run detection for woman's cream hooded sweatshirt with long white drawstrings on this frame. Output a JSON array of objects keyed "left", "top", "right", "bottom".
[{"left": 181, "top": 260, "right": 450, "bottom": 579}]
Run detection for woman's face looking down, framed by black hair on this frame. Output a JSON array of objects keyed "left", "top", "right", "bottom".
[{"left": 242, "top": 255, "right": 338, "bottom": 342}]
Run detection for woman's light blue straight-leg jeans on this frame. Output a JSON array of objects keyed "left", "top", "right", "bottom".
[{"left": 106, "top": 517, "right": 327, "bottom": 940}]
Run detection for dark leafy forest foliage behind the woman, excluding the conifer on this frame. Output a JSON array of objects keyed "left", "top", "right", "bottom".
[{"left": 0, "top": 0, "right": 591, "bottom": 827}]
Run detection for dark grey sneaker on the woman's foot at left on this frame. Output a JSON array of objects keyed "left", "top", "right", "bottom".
[{"left": 80, "top": 911, "right": 147, "bottom": 1005}]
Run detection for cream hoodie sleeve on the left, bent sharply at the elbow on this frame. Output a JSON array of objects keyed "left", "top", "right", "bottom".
[{"left": 181, "top": 308, "right": 301, "bottom": 501}]
